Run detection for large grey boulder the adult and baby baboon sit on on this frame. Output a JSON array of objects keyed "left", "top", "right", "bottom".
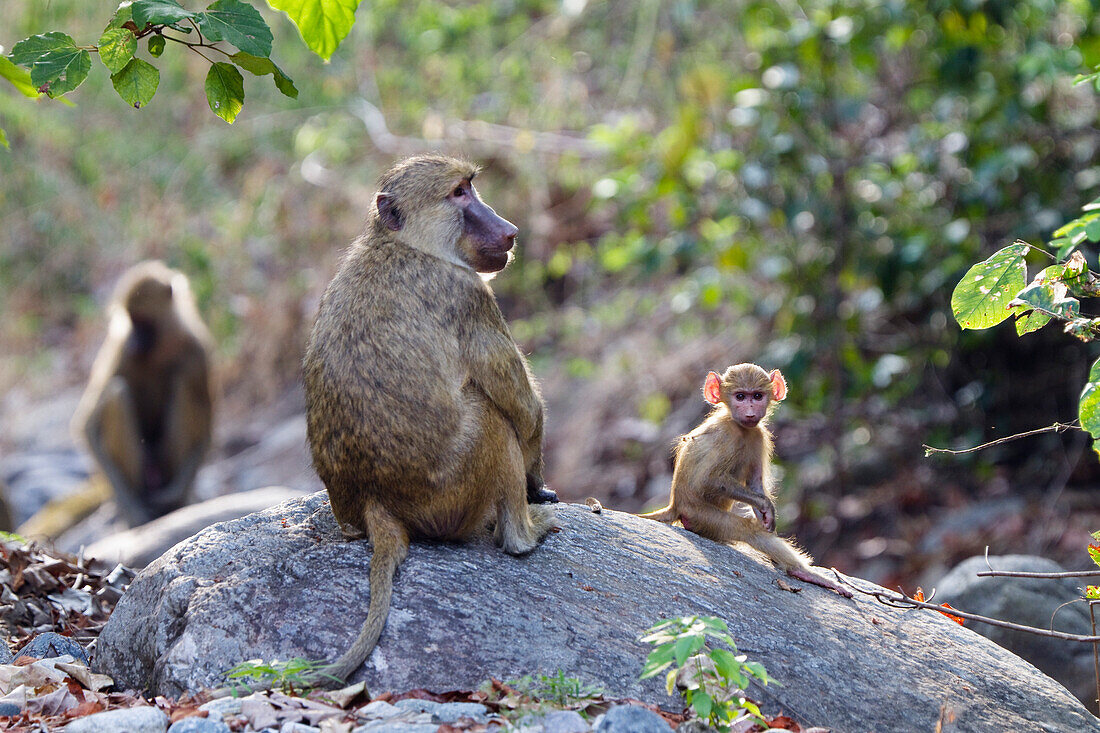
[{"left": 94, "top": 493, "right": 1100, "bottom": 733}]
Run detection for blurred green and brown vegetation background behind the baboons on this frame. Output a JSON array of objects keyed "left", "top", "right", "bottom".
[{"left": 0, "top": 0, "right": 1100, "bottom": 584}]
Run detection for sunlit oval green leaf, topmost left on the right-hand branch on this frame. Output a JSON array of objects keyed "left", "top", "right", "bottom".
[{"left": 952, "top": 243, "right": 1027, "bottom": 329}]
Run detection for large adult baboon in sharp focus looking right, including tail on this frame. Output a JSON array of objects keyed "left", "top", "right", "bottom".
[{"left": 304, "top": 155, "right": 554, "bottom": 679}]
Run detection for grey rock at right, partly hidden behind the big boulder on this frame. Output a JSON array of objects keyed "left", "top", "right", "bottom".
[{"left": 936, "top": 555, "right": 1097, "bottom": 712}]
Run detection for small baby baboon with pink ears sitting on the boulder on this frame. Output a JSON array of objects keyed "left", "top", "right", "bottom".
[{"left": 641, "top": 364, "right": 851, "bottom": 598}]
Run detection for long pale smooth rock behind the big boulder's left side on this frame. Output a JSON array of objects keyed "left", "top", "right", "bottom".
[{"left": 85, "top": 486, "right": 303, "bottom": 568}]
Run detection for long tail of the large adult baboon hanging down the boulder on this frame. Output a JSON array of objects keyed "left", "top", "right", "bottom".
[{"left": 325, "top": 508, "right": 409, "bottom": 680}]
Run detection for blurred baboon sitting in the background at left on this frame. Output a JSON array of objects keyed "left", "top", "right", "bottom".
[{"left": 73, "top": 261, "right": 213, "bottom": 526}]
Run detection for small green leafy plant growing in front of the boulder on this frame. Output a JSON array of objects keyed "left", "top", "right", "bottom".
[{"left": 640, "top": 616, "right": 778, "bottom": 731}]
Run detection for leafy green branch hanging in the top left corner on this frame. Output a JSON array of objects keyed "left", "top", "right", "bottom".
[{"left": 0, "top": 0, "right": 297, "bottom": 123}]
